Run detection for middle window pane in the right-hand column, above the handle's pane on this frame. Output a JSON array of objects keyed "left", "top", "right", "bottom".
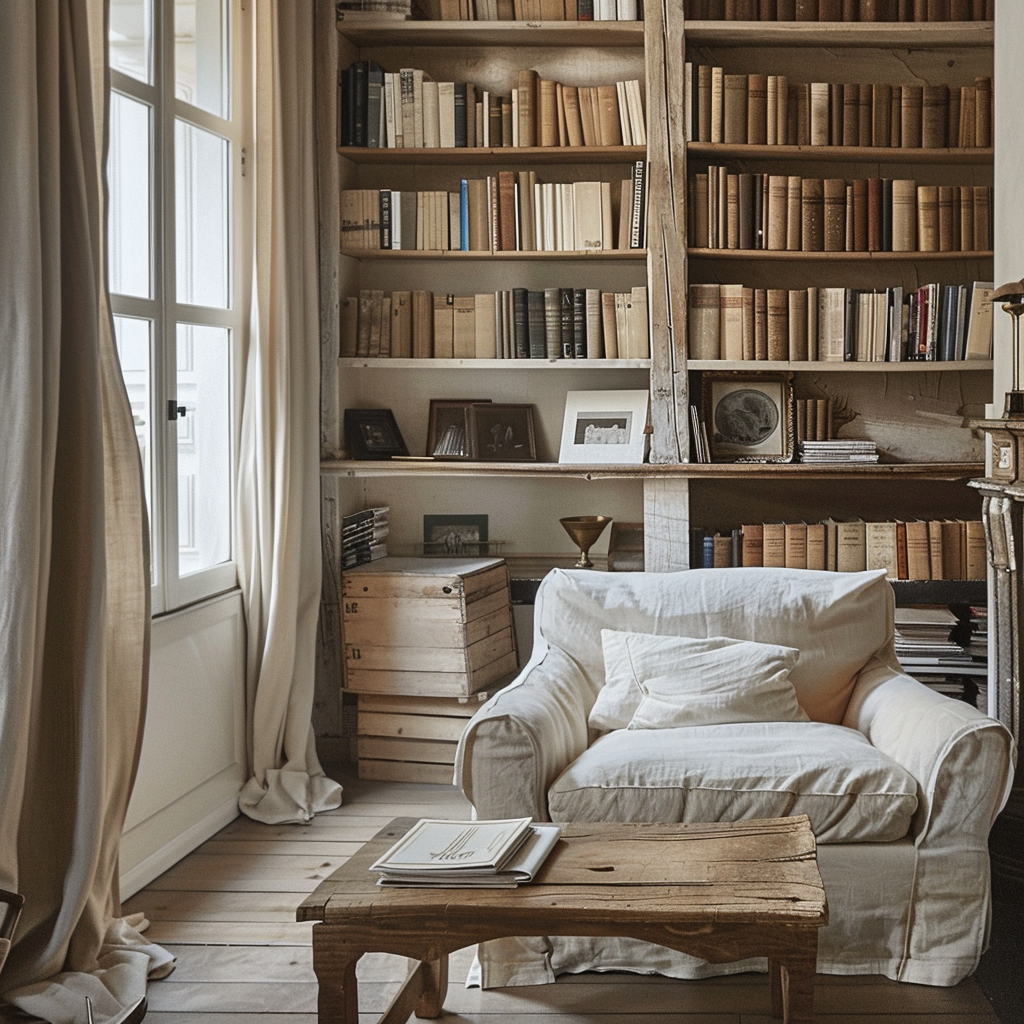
[{"left": 174, "top": 121, "right": 230, "bottom": 309}]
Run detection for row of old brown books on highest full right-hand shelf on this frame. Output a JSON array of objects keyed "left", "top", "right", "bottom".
[{"left": 683, "top": 62, "right": 993, "bottom": 150}]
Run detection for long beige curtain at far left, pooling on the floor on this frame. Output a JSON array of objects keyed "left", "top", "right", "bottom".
[{"left": 0, "top": 0, "right": 170, "bottom": 1022}]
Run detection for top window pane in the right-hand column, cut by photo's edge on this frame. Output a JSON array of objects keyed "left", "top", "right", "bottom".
[{"left": 174, "top": 0, "right": 230, "bottom": 118}]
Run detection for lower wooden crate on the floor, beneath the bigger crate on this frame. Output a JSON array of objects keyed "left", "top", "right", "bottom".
[{"left": 356, "top": 691, "right": 489, "bottom": 785}]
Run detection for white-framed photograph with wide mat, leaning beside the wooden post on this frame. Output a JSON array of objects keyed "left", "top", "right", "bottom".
[{"left": 558, "top": 390, "right": 650, "bottom": 465}]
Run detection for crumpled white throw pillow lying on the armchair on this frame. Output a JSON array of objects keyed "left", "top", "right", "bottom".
[{"left": 589, "top": 630, "right": 809, "bottom": 731}]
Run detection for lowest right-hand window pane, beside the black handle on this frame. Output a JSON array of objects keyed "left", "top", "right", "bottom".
[{"left": 177, "top": 324, "right": 231, "bottom": 575}]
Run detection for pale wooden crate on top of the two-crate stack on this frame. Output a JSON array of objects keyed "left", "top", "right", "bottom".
[{"left": 342, "top": 558, "right": 518, "bottom": 697}]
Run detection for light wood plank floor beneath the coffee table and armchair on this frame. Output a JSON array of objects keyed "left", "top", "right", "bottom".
[{"left": 125, "top": 769, "right": 998, "bottom": 1024}]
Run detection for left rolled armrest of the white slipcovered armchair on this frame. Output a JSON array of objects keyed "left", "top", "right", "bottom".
[{"left": 455, "top": 647, "right": 594, "bottom": 821}]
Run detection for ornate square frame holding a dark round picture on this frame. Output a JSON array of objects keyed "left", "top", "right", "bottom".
[{"left": 700, "top": 371, "right": 794, "bottom": 462}]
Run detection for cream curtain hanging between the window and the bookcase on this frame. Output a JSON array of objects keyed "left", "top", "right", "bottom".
[{"left": 239, "top": 0, "right": 341, "bottom": 822}]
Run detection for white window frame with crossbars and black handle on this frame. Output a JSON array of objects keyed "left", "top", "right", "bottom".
[{"left": 110, "top": 0, "right": 253, "bottom": 615}]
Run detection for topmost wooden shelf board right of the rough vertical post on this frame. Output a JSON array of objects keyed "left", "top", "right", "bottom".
[{"left": 686, "top": 20, "right": 995, "bottom": 50}]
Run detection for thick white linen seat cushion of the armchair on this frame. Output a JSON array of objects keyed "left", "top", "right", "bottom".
[{"left": 548, "top": 722, "right": 918, "bottom": 843}]
